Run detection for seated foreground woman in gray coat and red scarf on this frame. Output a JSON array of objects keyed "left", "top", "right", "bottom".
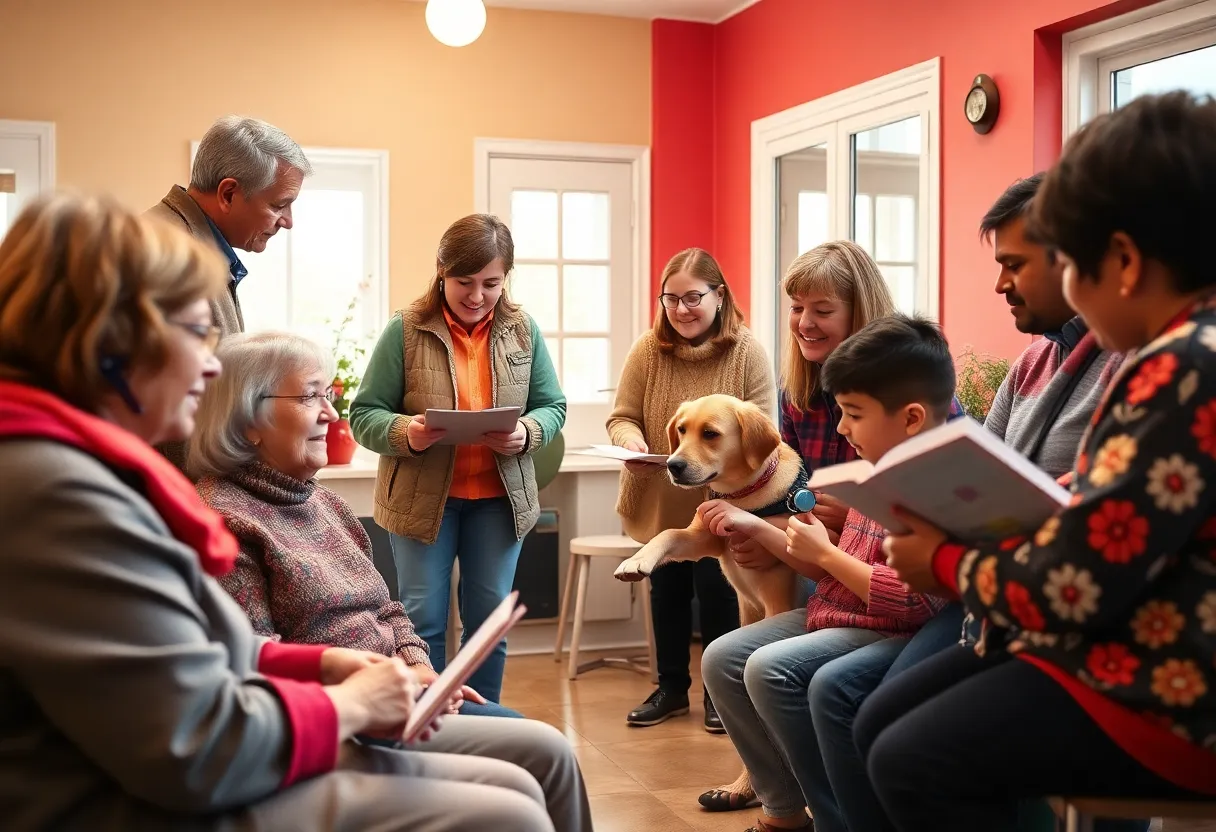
[{"left": 0, "top": 196, "right": 591, "bottom": 832}]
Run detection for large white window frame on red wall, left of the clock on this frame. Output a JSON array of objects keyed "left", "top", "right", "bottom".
[{"left": 750, "top": 58, "right": 941, "bottom": 369}]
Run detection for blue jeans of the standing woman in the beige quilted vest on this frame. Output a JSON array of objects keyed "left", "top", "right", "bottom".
[{"left": 389, "top": 497, "right": 523, "bottom": 702}]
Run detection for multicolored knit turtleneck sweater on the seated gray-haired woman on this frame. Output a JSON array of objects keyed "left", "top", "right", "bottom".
[{"left": 198, "top": 462, "right": 429, "bottom": 667}]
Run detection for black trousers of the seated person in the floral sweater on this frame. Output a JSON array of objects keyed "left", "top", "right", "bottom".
[{"left": 854, "top": 647, "right": 1199, "bottom": 832}]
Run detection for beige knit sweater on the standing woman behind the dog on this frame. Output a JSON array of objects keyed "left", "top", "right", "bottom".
[{"left": 608, "top": 327, "right": 776, "bottom": 543}]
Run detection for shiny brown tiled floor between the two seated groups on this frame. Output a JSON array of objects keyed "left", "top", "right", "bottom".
[{"left": 502, "top": 648, "right": 754, "bottom": 832}]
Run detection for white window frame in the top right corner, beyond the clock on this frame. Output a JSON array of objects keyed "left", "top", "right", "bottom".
[{"left": 1062, "top": 0, "right": 1216, "bottom": 140}]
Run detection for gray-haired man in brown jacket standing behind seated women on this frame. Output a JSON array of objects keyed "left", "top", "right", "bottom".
[{"left": 148, "top": 116, "right": 313, "bottom": 336}]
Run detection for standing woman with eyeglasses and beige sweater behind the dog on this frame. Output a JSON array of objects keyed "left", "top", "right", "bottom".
[{"left": 608, "top": 248, "right": 776, "bottom": 733}]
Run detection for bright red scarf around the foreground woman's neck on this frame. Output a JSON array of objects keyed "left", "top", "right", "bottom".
[{"left": 0, "top": 381, "right": 237, "bottom": 577}]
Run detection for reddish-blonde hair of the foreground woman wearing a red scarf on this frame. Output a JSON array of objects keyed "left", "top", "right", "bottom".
[{"left": 0, "top": 195, "right": 229, "bottom": 411}]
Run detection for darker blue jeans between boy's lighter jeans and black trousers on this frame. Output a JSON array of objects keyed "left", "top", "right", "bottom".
[{"left": 804, "top": 603, "right": 963, "bottom": 832}]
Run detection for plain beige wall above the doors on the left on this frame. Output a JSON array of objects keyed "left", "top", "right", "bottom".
[{"left": 0, "top": 0, "right": 651, "bottom": 308}]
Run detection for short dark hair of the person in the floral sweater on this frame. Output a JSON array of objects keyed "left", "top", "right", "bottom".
[{"left": 1031, "top": 91, "right": 1216, "bottom": 293}]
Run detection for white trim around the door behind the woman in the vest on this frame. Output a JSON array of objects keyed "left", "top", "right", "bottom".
[{"left": 473, "top": 139, "right": 651, "bottom": 343}]
